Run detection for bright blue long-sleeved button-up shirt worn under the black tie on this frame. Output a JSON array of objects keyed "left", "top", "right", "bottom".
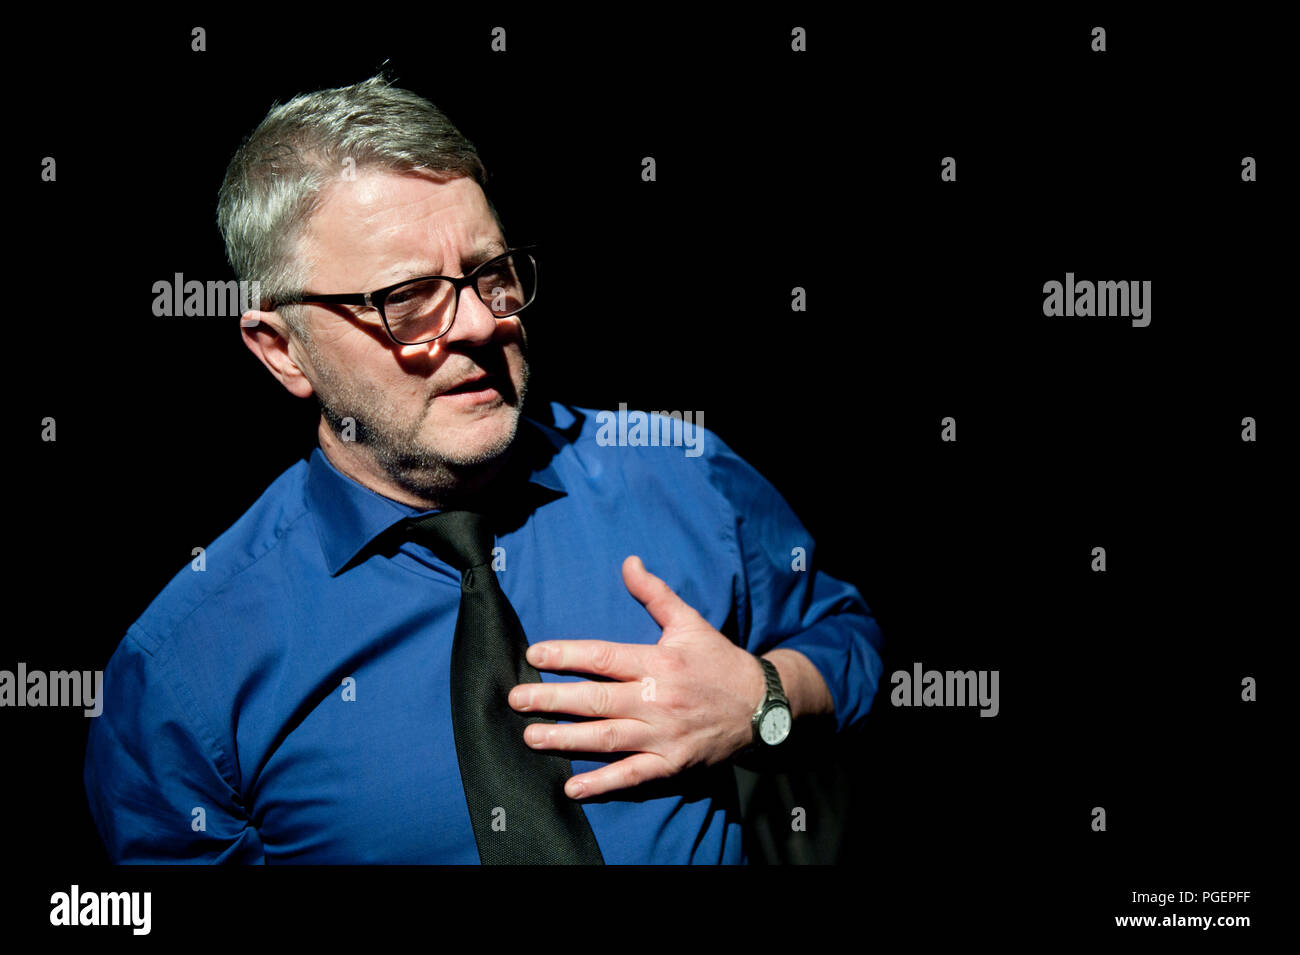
[{"left": 86, "top": 404, "right": 881, "bottom": 864}]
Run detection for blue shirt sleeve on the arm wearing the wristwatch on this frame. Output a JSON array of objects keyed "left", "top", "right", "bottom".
[{"left": 709, "top": 434, "right": 884, "bottom": 732}]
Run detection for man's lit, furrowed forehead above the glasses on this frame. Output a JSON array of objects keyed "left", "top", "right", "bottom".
[{"left": 304, "top": 170, "right": 502, "bottom": 285}]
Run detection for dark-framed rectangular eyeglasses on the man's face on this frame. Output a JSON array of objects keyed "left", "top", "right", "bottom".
[{"left": 269, "top": 246, "right": 537, "bottom": 344}]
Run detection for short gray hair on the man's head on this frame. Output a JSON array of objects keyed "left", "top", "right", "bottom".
[{"left": 217, "top": 73, "right": 501, "bottom": 342}]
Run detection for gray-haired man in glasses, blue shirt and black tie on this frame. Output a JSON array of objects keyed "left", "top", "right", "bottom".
[{"left": 86, "top": 77, "right": 881, "bottom": 863}]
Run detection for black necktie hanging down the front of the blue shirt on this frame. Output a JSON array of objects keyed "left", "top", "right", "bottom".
[{"left": 410, "top": 511, "right": 605, "bottom": 865}]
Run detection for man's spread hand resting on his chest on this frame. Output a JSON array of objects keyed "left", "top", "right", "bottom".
[{"left": 510, "top": 556, "right": 767, "bottom": 798}]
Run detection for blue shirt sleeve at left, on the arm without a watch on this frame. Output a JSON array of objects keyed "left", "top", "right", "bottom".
[{"left": 85, "top": 626, "right": 265, "bottom": 864}]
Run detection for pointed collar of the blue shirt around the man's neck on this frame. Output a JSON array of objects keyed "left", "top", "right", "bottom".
[{"left": 307, "top": 418, "right": 567, "bottom": 577}]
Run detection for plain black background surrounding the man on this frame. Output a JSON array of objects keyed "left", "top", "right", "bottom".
[{"left": 0, "top": 5, "right": 1279, "bottom": 942}]
